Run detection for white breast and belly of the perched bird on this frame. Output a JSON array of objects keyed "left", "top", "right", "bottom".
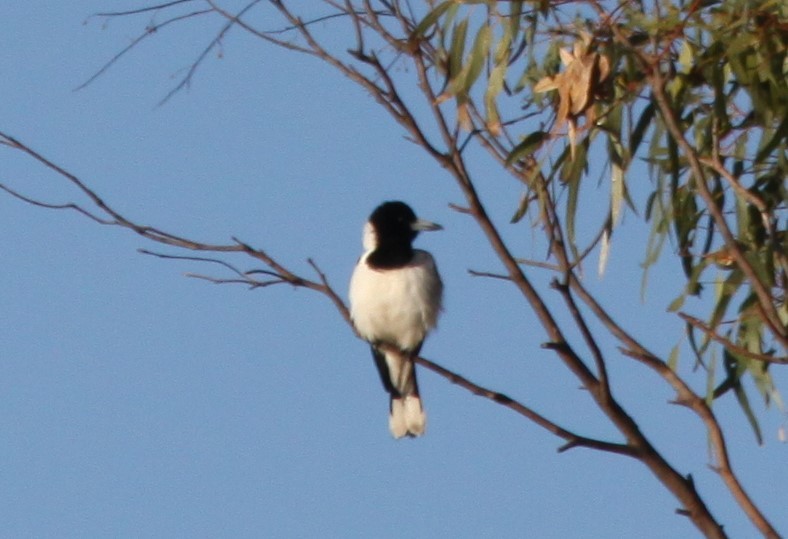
[{"left": 350, "top": 250, "right": 443, "bottom": 350}]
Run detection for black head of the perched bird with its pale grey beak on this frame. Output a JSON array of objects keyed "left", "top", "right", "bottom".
[{"left": 367, "top": 201, "right": 441, "bottom": 268}]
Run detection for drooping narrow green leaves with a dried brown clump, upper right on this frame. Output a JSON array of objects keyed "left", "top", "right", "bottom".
[{"left": 413, "top": 0, "right": 788, "bottom": 440}]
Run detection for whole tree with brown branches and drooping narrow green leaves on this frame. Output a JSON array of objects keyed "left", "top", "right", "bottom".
[{"left": 3, "top": 0, "right": 788, "bottom": 537}]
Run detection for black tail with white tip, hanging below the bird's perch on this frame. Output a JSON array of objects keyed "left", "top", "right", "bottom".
[{"left": 372, "top": 347, "right": 427, "bottom": 438}]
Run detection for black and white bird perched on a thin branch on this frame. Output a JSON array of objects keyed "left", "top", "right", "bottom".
[{"left": 350, "top": 202, "right": 443, "bottom": 438}]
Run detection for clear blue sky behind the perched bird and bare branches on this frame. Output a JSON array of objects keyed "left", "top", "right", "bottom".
[{"left": 0, "top": 0, "right": 788, "bottom": 539}]
